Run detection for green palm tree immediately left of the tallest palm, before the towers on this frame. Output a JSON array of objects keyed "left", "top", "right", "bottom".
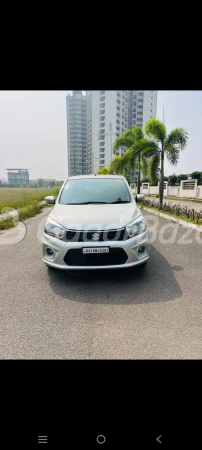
[{"left": 113, "top": 126, "right": 149, "bottom": 194}]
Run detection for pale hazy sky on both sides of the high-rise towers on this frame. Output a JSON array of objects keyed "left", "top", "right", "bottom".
[{"left": 0, "top": 91, "right": 202, "bottom": 180}]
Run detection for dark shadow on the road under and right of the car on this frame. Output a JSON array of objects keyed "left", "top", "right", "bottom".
[{"left": 48, "top": 246, "right": 183, "bottom": 305}]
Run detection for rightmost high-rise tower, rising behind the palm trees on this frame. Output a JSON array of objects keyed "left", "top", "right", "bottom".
[{"left": 128, "top": 91, "right": 157, "bottom": 131}]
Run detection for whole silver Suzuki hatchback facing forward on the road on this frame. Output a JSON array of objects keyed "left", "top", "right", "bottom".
[{"left": 42, "top": 175, "right": 149, "bottom": 270}]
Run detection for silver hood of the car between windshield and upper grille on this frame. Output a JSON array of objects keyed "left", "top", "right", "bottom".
[{"left": 49, "top": 203, "right": 141, "bottom": 230}]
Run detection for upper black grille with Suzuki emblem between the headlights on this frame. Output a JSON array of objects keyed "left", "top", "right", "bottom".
[{"left": 66, "top": 228, "right": 128, "bottom": 242}]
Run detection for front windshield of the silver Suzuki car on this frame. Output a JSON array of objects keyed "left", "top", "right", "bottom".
[{"left": 59, "top": 177, "right": 131, "bottom": 205}]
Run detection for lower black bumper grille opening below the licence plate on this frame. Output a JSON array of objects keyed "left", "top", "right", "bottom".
[{"left": 64, "top": 248, "right": 128, "bottom": 266}]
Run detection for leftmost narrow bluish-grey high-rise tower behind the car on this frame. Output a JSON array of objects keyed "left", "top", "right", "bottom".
[{"left": 66, "top": 91, "right": 88, "bottom": 176}]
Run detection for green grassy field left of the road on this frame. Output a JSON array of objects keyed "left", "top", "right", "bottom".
[{"left": 0, "top": 188, "right": 59, "bottom": 230}]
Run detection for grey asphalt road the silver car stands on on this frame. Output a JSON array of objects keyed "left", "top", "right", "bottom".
[{"left": 0, "top": 209, "right": 202, "bottom": 359}]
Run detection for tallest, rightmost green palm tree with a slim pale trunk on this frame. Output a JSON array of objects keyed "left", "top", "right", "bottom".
[{"left": 143, "top": 118, "right": 188, "bottom": 209}]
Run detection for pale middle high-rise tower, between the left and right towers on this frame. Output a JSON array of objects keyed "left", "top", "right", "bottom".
[{"left": 87, "top": 91, "right": 128, "bottom": 173}]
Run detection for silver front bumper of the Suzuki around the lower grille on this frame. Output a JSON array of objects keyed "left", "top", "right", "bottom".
[{"left": 42, "top": 230, "right": 149, "bottom": 270}]
